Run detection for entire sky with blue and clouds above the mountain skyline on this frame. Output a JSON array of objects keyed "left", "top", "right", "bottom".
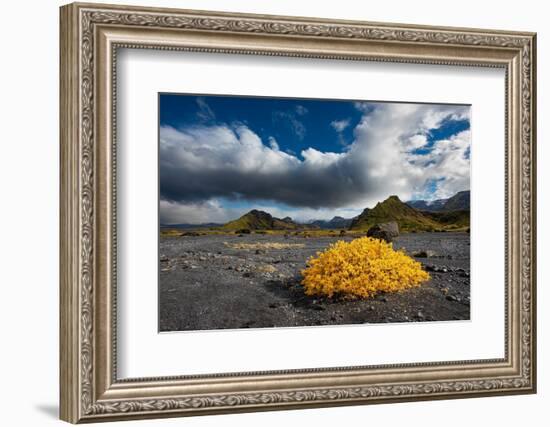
[{"left": 159, "top": 94, "right": 470, "bottom": 224}]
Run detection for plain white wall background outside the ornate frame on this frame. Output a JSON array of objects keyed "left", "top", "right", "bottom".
[{"left": 0, "top": 0, "right": 550, "bottom": 427}]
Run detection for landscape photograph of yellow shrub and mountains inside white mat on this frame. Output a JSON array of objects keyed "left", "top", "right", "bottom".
[{"left": 158, "top": 93, "right": 471, "bottom": 332}]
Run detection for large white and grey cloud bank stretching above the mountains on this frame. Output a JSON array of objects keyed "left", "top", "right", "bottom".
[{"left": 160, "top": 103, "right": 470, "bottom": 222}]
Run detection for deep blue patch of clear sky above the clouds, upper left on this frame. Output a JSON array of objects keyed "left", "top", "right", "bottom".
[{"left": 160, "top": 94, "right": 362, "bottom": 156}]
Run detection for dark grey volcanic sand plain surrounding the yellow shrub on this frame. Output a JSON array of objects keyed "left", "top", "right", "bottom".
[{"left": 159, "top": 233, "right": 470, "bottom": 331}]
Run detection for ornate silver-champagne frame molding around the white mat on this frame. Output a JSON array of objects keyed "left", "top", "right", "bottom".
[{"left": 60, "top": 3, "right": 536, "bottom": 423}]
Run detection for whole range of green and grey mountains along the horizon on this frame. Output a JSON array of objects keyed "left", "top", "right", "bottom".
[{"left": 161, "top": 191, "right": 470, "bottom": 232}]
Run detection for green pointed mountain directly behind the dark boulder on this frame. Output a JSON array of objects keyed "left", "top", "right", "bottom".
[{"left": 350, "top": 196, "right": 441, "bottom": 231}]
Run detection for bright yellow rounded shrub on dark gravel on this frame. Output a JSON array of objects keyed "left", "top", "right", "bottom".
[{"left": 302, "top": 237, "right": 430, "bottom": 298}]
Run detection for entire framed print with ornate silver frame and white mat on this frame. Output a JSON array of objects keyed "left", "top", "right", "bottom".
[{"left": 60, "top": 4, "right": 536, "bottom": 423}]
